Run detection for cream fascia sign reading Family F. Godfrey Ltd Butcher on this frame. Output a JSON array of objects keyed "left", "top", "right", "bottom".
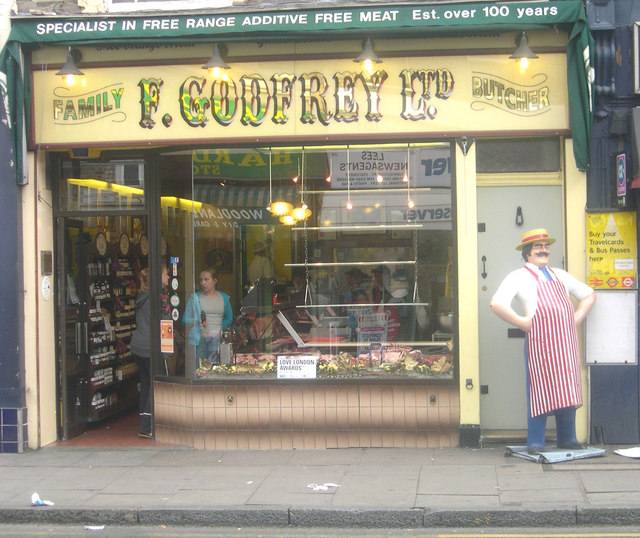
[{"left": 33, "top": 54, "right": 569, "bottom": 147}]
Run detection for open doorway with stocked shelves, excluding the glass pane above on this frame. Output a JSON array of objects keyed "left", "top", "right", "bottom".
[{"left": 58, "top": 217, "right": 148, "bottom": 440}]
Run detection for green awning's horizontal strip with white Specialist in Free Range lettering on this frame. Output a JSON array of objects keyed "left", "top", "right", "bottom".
[{"left": 9, "top": 0, "right": 583, "bottom": 43}]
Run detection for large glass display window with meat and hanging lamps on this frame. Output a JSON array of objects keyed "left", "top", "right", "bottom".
[{"left": 160, "top": 144, "right": 456, "bottom": 379}]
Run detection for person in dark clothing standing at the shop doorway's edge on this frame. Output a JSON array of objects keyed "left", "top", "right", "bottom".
[{"left": 129, "top": 265, "right": 169, "bottom": 439}]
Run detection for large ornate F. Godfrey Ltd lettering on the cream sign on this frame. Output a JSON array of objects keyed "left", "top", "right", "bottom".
[{"left": 138, "top": 69, "right": 454, "bottom": 129}]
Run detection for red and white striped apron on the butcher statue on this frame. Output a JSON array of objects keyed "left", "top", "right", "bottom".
[{"left": 525, "top": 267, "right": 582, "bottom": 417}]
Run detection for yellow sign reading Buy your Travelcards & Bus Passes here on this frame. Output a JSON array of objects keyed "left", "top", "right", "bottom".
[{"left": 587, "top": 213, "right": 637, "bottom": 289}]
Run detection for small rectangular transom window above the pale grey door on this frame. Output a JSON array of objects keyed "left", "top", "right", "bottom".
[{"left": 476, "top": 137, "right": 561, "bottom": 173}]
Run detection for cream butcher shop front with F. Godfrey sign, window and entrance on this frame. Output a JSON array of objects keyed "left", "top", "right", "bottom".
[{"left": 2, "top": 2, "right": 588, "bottom": 449}]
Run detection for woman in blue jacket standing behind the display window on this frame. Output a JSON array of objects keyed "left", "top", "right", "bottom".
[{"left": 183, "top": 267, "right": 233, "bottom": 373}]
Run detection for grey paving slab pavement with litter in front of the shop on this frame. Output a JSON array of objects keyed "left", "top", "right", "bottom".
[{"left": 0, "top": 446, "right": 640, "bottom": 528}]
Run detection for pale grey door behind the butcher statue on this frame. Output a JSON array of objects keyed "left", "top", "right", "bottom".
[{"left": 478, "top": 186, "right": 564, "bottom": 431}]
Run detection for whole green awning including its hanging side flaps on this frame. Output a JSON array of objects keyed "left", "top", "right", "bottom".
[{"left": 0, "top": 0, "right": 593, "bottom": 184}]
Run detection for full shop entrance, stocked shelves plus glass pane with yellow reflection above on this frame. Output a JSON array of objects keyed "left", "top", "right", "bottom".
[{"left": 50, "top": 155, "right": 151, "bottom": 441}]
